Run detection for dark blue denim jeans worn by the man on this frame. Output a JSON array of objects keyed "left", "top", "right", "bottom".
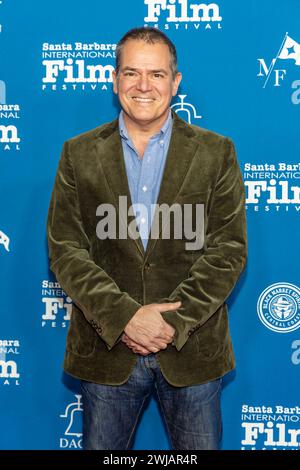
[{"left": 81, "top": 353, "right": 222, "bottom": 450}]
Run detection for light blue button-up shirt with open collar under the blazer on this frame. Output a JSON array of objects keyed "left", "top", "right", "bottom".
[{"left": 119, "top": 110, "right": 173, "bottom": 251}]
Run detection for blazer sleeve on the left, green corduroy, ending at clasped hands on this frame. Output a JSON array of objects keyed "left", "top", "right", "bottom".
[{"left": 47, "top": 142, "right": 141, "bottom": 350}]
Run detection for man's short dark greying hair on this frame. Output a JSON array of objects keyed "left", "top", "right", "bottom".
[{"left": 116, "top": 26, "right": 177, "bottom": 78}]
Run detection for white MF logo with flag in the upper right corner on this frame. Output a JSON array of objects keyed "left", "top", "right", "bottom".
[{"left": 257, "top": 33, "right": 300, "bottom": 105}]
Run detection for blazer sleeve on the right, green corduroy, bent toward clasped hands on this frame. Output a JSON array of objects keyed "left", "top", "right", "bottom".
[{"left": 159, "top": 138, "right": 247, "bottom": 351}]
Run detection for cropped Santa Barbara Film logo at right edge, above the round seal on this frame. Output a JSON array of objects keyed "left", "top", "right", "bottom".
[{"left": 243, "top": 162, "right": 300, "bottom": 212}]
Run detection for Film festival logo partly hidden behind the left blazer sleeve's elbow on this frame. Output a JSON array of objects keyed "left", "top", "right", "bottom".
[{"left": 41, "top": 279, "right": 72, "bottom": 328}]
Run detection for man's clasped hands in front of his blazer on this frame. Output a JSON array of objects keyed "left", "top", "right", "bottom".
[{"left": 121, "top": 302, "right": 181, "bottom": 356}]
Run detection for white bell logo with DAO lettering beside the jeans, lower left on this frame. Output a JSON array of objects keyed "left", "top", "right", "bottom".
[{"left": 59, "top": 395, "right": 82, "bottom": 449}]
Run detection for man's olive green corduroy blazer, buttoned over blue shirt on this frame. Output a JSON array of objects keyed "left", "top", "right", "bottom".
[{"left": 47, "top": 112, "right": 247, "bottom": 387}]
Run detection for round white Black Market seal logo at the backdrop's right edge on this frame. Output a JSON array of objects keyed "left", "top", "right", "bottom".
[{"left": 257, "top": 282, "right": 300, "bottom": 333}]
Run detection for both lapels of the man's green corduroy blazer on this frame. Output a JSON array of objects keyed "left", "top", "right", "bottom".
[{"left": 98, "top": 111, "right": 198, "bottom": 261}]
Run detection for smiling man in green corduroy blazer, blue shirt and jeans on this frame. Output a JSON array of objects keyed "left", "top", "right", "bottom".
[{"left": 48, "top": 28, "right": 247, "bottom": 450}]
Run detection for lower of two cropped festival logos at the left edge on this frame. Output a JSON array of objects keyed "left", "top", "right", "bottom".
[{"left": 0, "top": 339, "right": 20, "bottom": 385}]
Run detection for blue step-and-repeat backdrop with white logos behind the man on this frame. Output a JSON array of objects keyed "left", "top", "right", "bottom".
[{"left": 0, "top": 0, "right": 300, "bottom": 450}]
